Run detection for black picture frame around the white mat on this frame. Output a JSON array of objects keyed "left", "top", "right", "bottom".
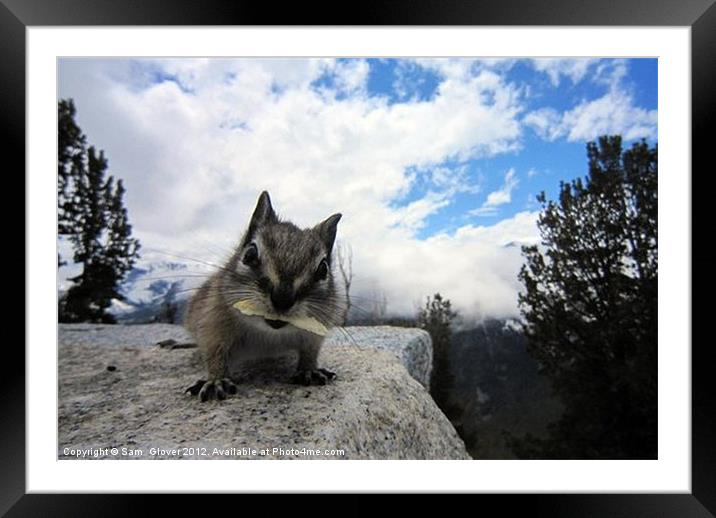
[{"left": 0, "top": 0, "right": 716, "bottom": 518}]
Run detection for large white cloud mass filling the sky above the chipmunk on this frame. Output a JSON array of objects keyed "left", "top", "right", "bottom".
[{"left": 59, "top": 59, "right": 536, "bottom": 316}]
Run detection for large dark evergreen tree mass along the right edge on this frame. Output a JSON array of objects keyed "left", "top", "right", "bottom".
[{"left": 513, "top": 136, "right": 658, "bottom": 458}]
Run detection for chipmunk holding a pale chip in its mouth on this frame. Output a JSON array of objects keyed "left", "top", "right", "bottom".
[{"left": 185, "top": 191, "right": 346, "bottom": 401}]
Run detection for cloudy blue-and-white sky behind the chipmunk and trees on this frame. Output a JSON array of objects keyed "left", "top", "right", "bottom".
[{"left": 58, "top": 59, "right": 657, "bottom": 318}]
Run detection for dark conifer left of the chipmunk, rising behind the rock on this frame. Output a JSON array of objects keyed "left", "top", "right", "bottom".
[{"left": 58, "top": 101, "right": 139, "bottom": 323}]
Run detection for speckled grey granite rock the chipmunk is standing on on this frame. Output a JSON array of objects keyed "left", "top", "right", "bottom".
[{"left": 58, "top": 324, "right": 469, "bottom": 459}]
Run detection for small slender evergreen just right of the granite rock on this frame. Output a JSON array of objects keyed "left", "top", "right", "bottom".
[{"left": 418, "top": 293, "right": 457, "bottom": 417}]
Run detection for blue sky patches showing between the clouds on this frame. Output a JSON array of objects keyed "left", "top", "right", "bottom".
[{"left": 358, "top": 59, "right": 658, "bottom": 238}]
